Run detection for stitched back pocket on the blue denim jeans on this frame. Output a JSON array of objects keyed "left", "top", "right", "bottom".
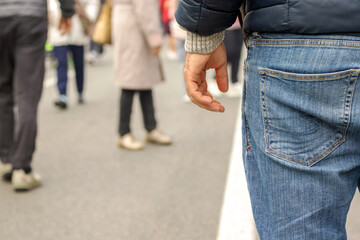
[{"left": 259, "top": 68, "right": 360, "bottom": 166}]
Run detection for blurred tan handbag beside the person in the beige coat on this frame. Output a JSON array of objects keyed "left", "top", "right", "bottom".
[{"left": 92, "top": 0, "right": 112, "bottom": 44}]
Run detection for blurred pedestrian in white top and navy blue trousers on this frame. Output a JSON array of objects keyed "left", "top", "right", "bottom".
[{"left": 48, "top": 0, "right": 90, "bottom": 110}]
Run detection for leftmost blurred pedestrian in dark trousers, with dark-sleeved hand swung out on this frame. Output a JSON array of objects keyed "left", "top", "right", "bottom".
[{"left": 0, "top": 0, "right": 74, "bottom": 190}]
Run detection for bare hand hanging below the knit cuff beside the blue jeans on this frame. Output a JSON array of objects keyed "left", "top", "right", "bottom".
[{"left": 184, "top": 44, "right": 228, "bottom": 112}]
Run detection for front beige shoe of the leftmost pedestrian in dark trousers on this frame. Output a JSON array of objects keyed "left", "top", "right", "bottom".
[{"left": 11, "top": 169, "right": 41, "bottom": 191}]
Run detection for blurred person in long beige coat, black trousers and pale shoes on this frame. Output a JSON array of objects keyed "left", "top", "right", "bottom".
[{"left": 112, "top": 0, "right": 171, "bottom": 150}]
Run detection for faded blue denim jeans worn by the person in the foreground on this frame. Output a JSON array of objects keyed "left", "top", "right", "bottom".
[{"left": 243, "top": 34, "right": 360, "bottom": 240}]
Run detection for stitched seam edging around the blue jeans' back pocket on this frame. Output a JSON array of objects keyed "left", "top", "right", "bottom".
[{"left": 259, "top": 68, "right": 360, "bottom": 167}]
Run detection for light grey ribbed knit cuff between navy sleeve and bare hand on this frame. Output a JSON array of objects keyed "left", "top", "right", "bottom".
[{"left": 185, "top": 31, "right": 224, "bottom": 54}]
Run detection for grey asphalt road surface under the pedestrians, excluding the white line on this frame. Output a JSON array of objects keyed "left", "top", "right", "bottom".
[{"left": 0, "top": 48, "right": 360, "bottom": 240}]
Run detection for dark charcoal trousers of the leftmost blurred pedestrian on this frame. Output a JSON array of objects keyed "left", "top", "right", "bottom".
[{"left": 0, "top": 17, "right": 47, "bottom": 170}]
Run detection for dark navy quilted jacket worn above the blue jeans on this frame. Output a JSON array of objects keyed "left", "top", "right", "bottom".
[{"left": 176, "top": 0, "right": 360, "bottom": 36}]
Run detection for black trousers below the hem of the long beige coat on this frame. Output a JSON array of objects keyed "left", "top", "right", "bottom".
[{"left": 119, "top": 89, "right": 156, "bottom": 136}]
